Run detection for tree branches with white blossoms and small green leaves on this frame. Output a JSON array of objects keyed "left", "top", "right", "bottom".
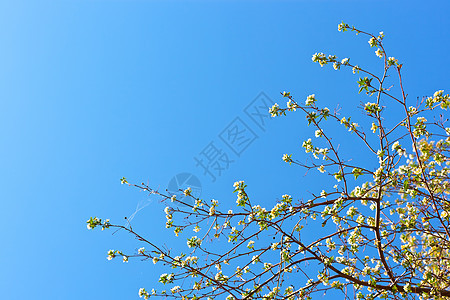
[{"left": 87, "top": 23, "right": 450, "bottom": 299}]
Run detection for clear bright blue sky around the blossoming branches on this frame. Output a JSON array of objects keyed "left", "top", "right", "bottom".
[{"left": 0, "top": 0, "right": 450, "bottom": 300}]
